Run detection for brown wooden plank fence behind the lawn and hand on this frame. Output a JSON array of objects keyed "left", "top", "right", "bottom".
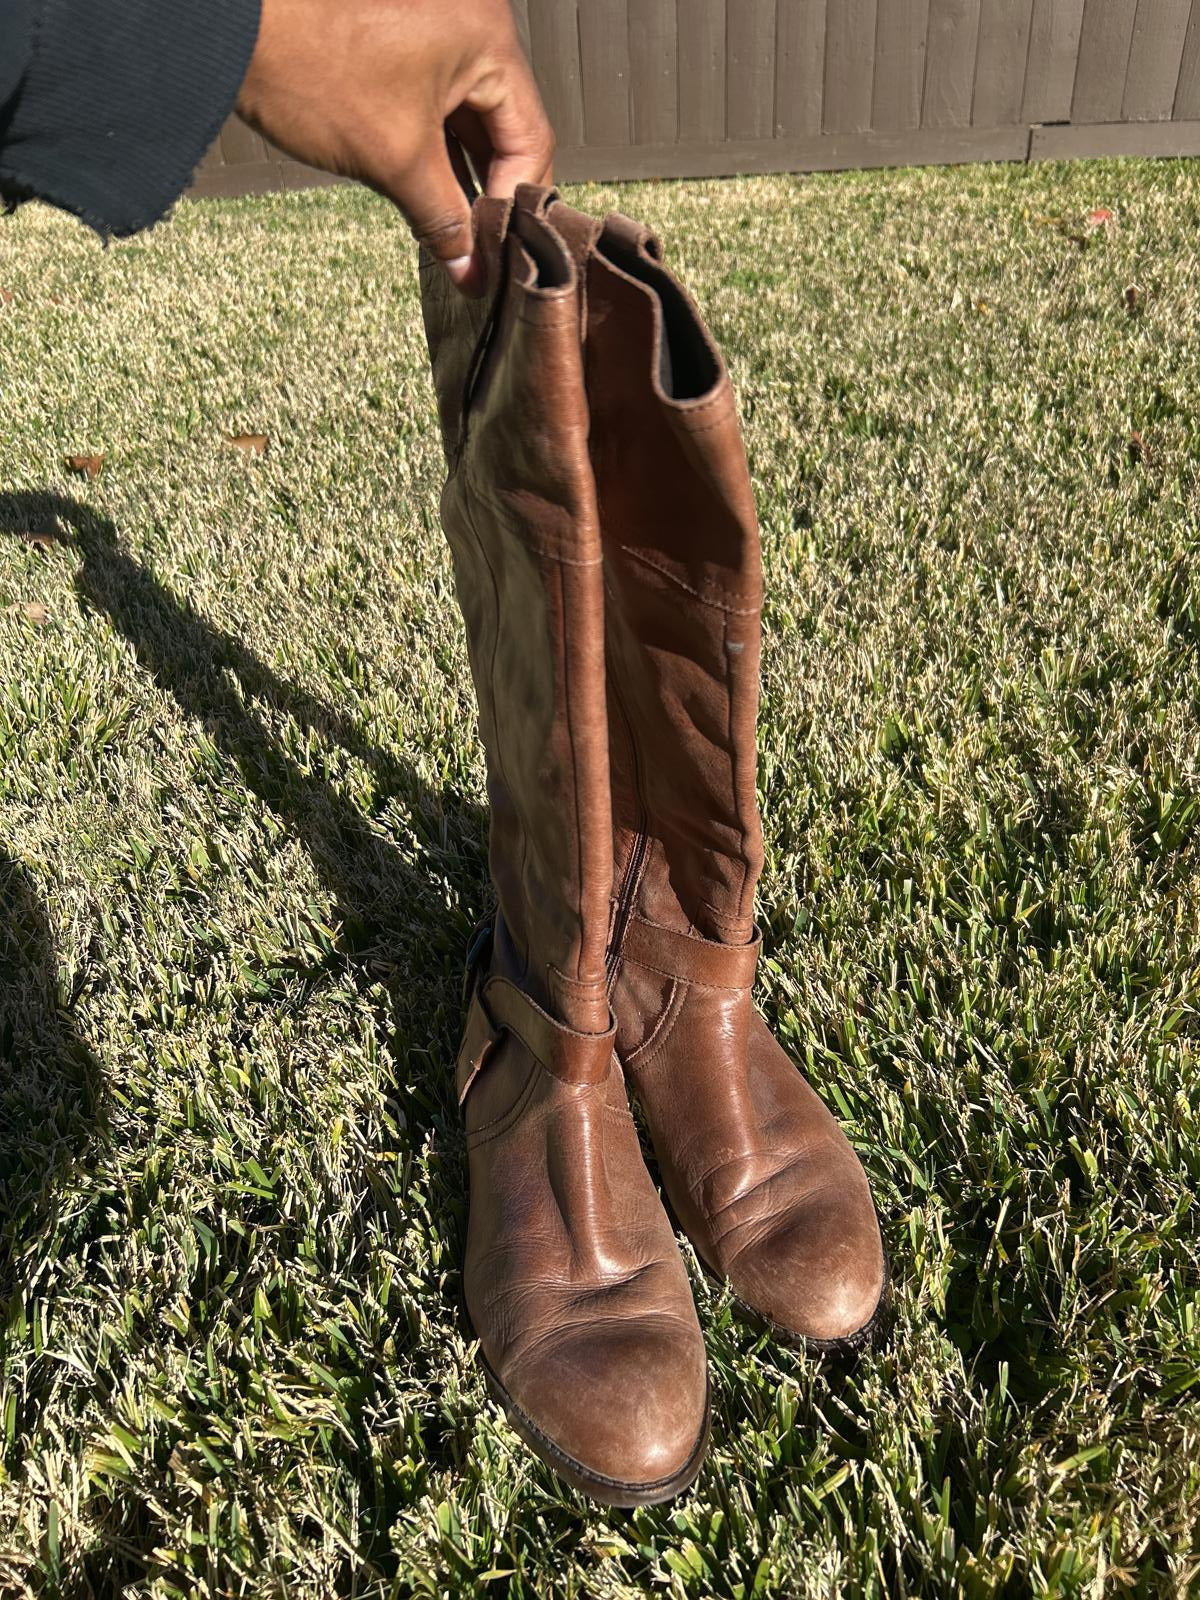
[{"left": 185, "top": 0, "right": 1200, "bottom": 195}]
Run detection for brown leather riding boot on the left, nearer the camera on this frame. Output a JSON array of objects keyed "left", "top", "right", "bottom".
[{"left": 422, "top": 200, "right": 709, "bottom": 1506}]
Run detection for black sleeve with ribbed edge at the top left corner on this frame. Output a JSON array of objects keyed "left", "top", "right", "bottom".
[{"left": 0, "top": 0, "right": 259, "bottom": 235}]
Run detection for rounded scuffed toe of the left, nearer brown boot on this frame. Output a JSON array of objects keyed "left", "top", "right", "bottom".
[{"left": 502, "top": 1318, "right": 709, "bottom": 1506}]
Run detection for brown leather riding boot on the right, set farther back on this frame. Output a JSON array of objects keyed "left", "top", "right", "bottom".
[{"left": 531, "top": 189, "right": 886, "bottom": 1349}]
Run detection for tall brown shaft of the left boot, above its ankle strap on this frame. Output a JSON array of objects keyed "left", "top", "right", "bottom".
[{"left": 422, "top": 202, "right": 613, "bottom": 1032}]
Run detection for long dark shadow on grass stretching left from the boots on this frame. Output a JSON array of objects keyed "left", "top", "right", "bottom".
[{"left": 0, "top": 493, "right": 488, "bottom": 1133}]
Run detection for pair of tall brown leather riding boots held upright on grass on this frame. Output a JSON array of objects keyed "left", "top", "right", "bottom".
[{"left": 422, "top": 187, "right": 886, "bottom": 1506}]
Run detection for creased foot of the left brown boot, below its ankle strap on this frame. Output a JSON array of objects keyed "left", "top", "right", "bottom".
[{"left": 462, "top": 1006, "right": 709, "bottom": 1506}]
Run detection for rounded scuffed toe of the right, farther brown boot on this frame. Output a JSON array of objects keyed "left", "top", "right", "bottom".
[{"left": 726, "top": 1184, "right": 886, "bottom": 1347}]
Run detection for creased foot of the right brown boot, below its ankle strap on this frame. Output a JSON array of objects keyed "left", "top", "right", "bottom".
[{"left": 616, "top": 960, "right": 886, "bottom": 1350}]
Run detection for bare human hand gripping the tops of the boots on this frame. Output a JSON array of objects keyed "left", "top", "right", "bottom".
[{"left": 237, "top": 0, "right": 554, "bottom": 294}]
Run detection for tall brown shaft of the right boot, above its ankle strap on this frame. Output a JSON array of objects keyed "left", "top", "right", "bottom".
[{"left": 531, "top": 190, "right": 762, "bottom": 944}]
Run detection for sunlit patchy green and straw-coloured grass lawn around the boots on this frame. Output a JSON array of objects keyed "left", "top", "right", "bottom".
[{"left": 0, "top": 152, "right": 1200, "bottom": 1600}]
